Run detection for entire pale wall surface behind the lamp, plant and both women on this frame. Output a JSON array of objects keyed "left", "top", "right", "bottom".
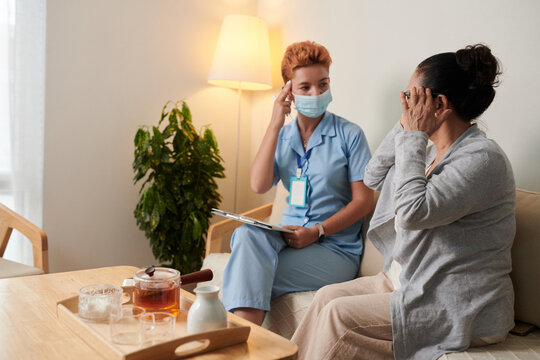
[{"left": 43, "top": 0, "right": 540, "bottom": 271}]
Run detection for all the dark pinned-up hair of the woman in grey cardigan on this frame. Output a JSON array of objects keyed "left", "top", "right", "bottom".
[{"left": 418, "top": 44, "right": 501, "bottom": 121}]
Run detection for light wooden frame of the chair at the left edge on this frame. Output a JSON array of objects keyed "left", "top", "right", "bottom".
[{"left": 0, "top": 204, "right": 49, "bottom": 273}]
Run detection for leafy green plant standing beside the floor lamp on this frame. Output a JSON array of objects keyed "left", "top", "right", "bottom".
[{"left": 133, "top": 101, "right": 225, "bottom": 274}]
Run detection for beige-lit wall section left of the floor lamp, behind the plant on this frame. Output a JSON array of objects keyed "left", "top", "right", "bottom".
[{"left": 43, "top": 0, "right": 255, "bottom": 271}]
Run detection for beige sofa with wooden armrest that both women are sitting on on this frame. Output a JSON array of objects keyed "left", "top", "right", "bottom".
[{"left": 202, "top": 185, "right": 540, "bottom": 360}]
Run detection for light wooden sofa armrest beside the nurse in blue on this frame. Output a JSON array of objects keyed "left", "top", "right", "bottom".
[{"left": 205, "top": 203, "right": 272, "bottom": 256}]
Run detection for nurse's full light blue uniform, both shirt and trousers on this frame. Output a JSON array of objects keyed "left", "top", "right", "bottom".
[{"left": 222, "top": 111, "right": 371, "bottom": 311}]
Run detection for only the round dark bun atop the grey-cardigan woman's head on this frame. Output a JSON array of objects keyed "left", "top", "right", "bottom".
[{"left": 456, "top": 44, "right": 501, "bottom": 90}]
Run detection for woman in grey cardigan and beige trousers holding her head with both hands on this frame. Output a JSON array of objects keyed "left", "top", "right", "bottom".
[{"left": 292, "top": 45, "right": 515, "bottom": 360}]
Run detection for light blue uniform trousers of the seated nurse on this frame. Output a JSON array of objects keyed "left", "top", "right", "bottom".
[{"left": 222, "top": 225, "right": 360, "bottom": 311}]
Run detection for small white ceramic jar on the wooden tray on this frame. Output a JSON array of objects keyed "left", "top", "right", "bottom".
[{"left": 187, "top": 285, "right": 227, "bottom": 334}]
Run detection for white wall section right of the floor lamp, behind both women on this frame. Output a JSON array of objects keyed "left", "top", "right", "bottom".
[{"left": 252, "top": 0, "right": 540, "bottom": 211}]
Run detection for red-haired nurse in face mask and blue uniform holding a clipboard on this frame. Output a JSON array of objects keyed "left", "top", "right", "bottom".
[{"left": 223, "top": 41, "right": 373, "bottom": 325}]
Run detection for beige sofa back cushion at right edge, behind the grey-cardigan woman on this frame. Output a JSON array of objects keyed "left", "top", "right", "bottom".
[{"left": 510, "top": 189, "right": 540, "bottom": 327}]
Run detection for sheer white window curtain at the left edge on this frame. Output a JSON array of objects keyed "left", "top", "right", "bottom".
[{"left": 0, "top": 0, "right": 46, "bottom": 265}]
